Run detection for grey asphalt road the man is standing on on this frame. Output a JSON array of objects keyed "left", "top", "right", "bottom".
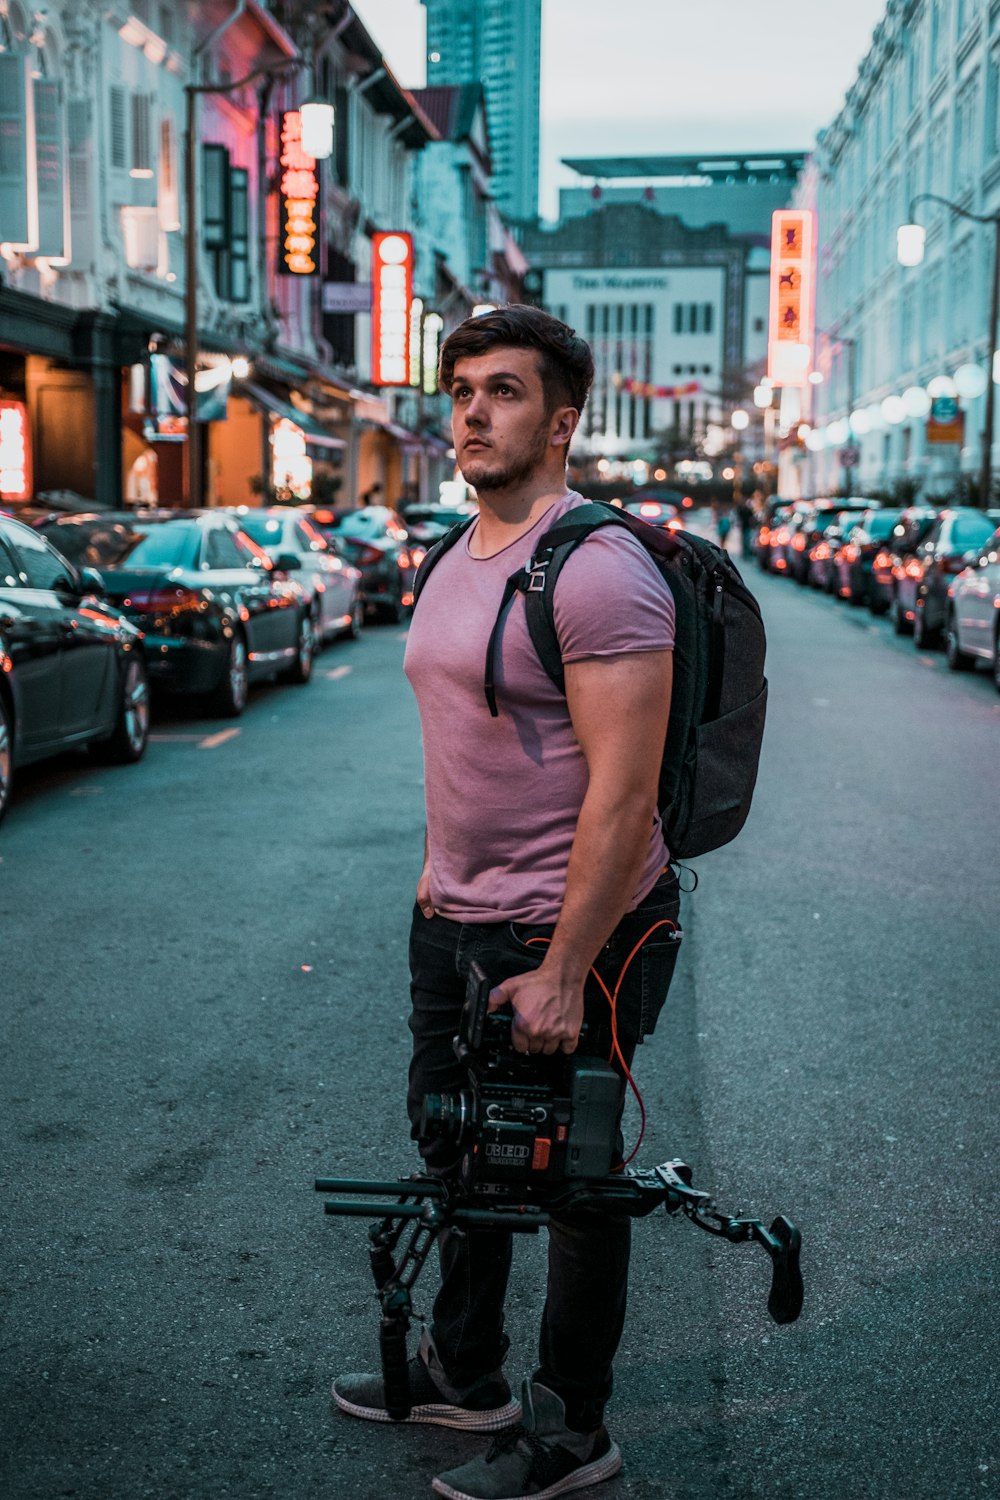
[{"left": 0, "top": 572, "right": 1000, "bottom": 1500}]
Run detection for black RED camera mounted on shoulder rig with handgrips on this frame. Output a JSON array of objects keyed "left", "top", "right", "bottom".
[{"left": 315, "top": 963, "right": 802, "bottom": 1422}]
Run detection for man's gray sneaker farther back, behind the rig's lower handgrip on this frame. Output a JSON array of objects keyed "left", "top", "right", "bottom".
[{"left": 333, "top": 1329, "right": 520, "bottom": 1433}]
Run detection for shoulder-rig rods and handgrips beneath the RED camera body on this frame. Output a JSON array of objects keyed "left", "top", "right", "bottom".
[{"left": 315, "top": 1161, "right": 802, "bottom": 1422}]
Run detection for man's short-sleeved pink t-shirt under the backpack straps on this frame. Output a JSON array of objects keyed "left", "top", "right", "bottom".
[{"left": 405, "top": 494, "right": 673, "bottom": 923}]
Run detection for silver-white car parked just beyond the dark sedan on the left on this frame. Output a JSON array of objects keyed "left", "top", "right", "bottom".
[{"left": 234, "top": 506, "right": 364, "bottom": 647}]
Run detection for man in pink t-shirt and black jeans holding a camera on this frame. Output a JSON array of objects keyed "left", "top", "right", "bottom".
[{"left": 333, "top": 306, "right": 679, "bottom": 1500}]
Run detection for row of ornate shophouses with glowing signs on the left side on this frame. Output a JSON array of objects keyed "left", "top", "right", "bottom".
[{"left": 0, "top": 0, "right": 515, "bottom": 506}]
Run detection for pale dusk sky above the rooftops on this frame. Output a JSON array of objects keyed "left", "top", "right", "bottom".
[{"left": 355, "top": 0, "right": 886, "bottom": 219}]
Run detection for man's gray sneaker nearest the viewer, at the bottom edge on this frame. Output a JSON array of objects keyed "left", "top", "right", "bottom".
[{"left": 433, "top": 1380, "right": 622, "bottom": 1500}]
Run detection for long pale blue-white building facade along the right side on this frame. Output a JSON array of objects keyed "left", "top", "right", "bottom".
[{"left": 783, "top": 0, "right": 1000, "bottom": 497}]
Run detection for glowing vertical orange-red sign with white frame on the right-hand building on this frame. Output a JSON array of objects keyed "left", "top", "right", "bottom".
[{"left": 768, "top": 209, "right": 816, "bottom": 386}]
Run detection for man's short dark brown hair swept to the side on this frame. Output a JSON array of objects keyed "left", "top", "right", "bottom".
[{"left": 439, "top": 303, "right": 594, "bottom": 416}]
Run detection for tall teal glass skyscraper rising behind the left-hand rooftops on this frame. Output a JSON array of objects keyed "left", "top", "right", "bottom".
[{"left": 423, "top": 0, "right": 541, "bottom": 221}]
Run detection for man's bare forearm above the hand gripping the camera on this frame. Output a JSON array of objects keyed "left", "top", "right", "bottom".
[{"left": 544, "top": 783, "right": 655, "bottom": 984}]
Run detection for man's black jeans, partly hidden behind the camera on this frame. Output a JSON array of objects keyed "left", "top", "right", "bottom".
[{"left": 408, "top": 872, "right": 679, "bottom": 1433}]
